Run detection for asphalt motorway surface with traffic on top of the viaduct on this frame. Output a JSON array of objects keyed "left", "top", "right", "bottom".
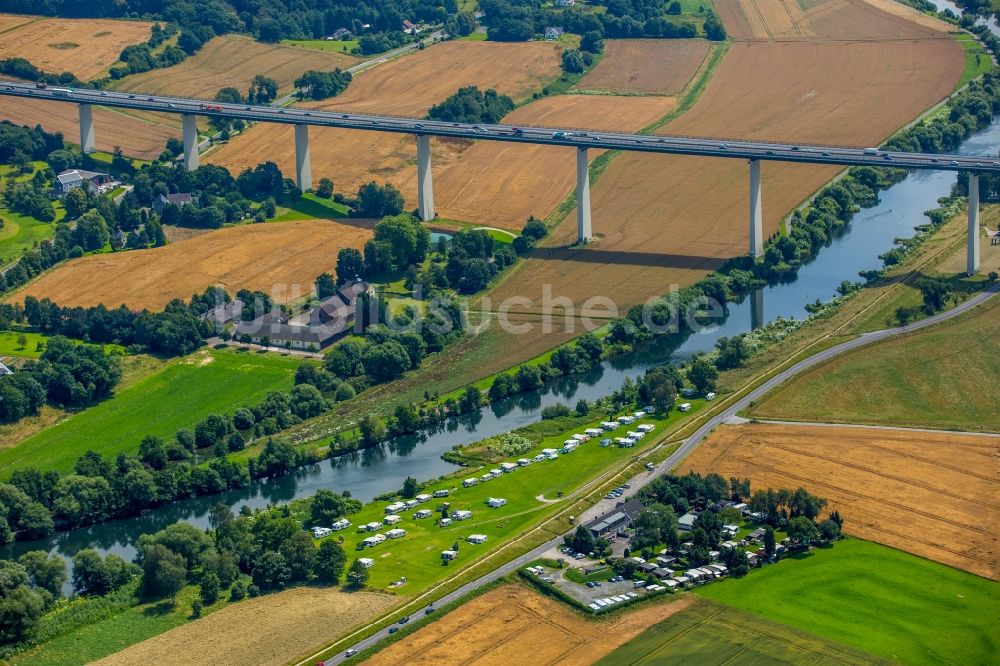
[{"left": 0, "top": 79, "right": 1000, "bottom": 173}]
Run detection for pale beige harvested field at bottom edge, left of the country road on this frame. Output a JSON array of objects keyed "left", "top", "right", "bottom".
[{"left": 94, "top": 587, "right": 392, "bottom": 666}]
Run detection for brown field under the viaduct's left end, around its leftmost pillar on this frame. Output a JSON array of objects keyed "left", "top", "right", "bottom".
[{"left": 0, "top": 96, "right": 181, "bottom": 160}]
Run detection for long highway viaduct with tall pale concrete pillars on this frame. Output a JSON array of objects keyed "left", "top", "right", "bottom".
[{"left": 0, "top": 81, "right": 1000, "bottom": 274}]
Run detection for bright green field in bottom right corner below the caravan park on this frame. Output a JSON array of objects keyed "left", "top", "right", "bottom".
[{"left": 698, "top": 538, "right": 1000, "bottom": 664}]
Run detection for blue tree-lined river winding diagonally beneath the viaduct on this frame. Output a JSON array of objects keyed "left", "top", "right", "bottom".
[{"left": 0, "top": 118, "right": 1000, "bottom": 591}]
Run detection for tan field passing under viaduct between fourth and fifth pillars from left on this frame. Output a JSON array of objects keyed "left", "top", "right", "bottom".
[{"left": 434, "top": 95, "right": 676, "bottom": 230}]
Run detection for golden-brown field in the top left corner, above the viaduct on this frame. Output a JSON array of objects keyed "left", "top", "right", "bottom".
[{"left": 0, "top": 16, "right": 153, "bottom": 81}]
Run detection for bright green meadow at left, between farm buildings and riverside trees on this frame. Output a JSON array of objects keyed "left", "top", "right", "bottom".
[{"left": 0, "top": 349, "right": 302, "bottom": 478}]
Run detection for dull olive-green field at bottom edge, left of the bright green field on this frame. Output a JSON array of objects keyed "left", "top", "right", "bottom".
[{"left": 597, "top": 599, "right": 877, "bottom": 666}]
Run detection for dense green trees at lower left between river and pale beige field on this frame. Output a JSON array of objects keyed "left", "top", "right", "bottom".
[{"left": 0, "top": 492, "right": 361, "bottom": 649}]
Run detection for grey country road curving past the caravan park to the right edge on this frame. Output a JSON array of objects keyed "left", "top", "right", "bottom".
[{"left": 321, "top": 283, "right": 1000, "bottom": 664}]
